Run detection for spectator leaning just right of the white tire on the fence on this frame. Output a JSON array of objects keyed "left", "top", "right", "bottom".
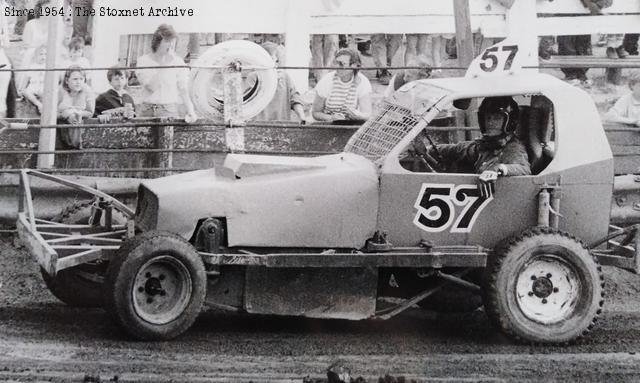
[{"left": 254, "top": 42, "right": 310, "bottom": 123}]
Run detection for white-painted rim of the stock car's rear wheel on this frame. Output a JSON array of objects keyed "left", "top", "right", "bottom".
[{"left": 515, "top": 254, "right": 581, "bottom": 324}]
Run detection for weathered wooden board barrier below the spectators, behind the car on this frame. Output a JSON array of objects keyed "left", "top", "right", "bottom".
[{"left": 0, "top": 116, "right": 640, "bottom": 178}]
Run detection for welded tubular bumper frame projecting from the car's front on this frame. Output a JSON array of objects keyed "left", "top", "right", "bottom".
[{"left": 16, "top": 169, "right": 135, "bottom": 276}]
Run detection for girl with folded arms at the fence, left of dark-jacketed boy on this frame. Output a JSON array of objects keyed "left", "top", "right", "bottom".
[{"left": 58, "top": 67, "right": 95, "bottom": 149}]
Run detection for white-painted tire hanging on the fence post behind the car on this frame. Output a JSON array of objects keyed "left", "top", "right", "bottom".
[{"left": 189, "top": 40, "right": 278, "bottom": 120}]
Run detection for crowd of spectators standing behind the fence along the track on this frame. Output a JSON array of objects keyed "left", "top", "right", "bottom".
[{"left": 1, "top": 0, "right": 640, "bottom": 148}]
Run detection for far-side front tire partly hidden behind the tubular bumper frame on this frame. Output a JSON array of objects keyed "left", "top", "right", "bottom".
[{"left": 40, "top": 201, "right": 126, "bottom": 308}]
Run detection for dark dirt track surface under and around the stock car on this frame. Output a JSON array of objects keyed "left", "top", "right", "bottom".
[{"left": 0, "top": 240, "right": 640, "bottom": 382}]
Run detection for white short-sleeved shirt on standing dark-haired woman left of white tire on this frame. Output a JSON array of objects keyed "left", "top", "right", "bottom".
[{"left": 136, "top": 54, "right": 189, "bottom": 104}]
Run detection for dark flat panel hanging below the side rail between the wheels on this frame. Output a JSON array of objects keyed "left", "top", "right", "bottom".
[{"left": 245, "top": 267, "right": 378, "bottom": 320}]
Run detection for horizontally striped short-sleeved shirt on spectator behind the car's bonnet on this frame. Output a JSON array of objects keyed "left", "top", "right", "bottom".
[{"left": 316, "top": 72, "right": 372, "bottom": 114}]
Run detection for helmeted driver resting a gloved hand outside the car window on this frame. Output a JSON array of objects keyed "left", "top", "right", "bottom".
[{"left": 416, "top": 97, "right": 531, "bottom": 198}]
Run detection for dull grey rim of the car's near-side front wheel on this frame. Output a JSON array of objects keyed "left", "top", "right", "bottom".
[{"left": 132, "top": 255, "right": 192, "bottom": 325}]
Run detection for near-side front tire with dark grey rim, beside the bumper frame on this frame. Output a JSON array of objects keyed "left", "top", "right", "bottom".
[{"left": 104, "top": 231, "right": 206, "bottom": 340}]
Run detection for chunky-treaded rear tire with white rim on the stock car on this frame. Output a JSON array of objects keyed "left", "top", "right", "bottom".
[{"left": 484, "top": 228, "right": 604, "bottom": 344}]
